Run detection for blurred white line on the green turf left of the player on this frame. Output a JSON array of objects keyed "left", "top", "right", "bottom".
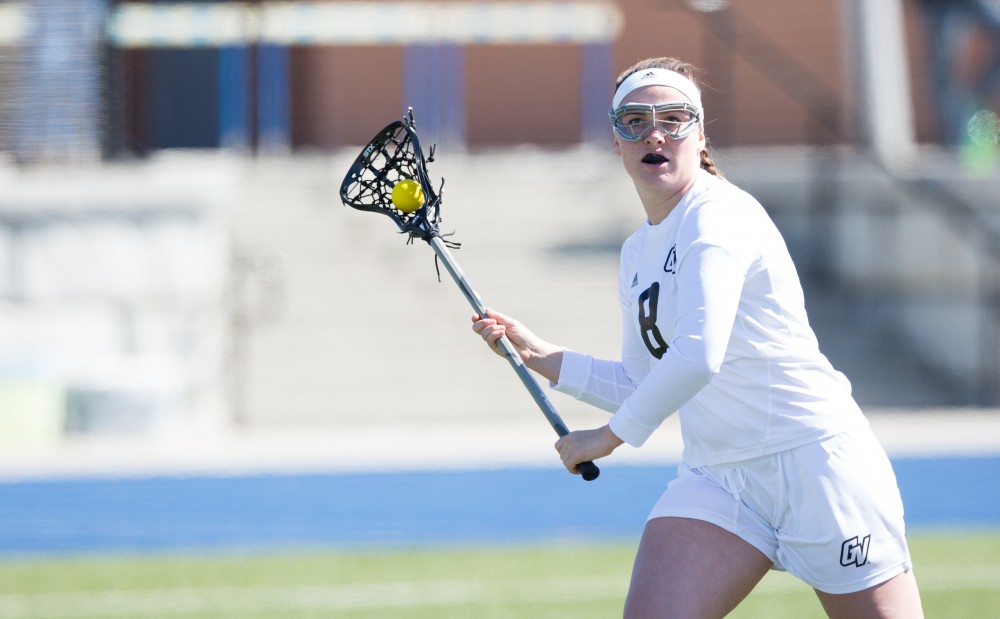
[{"left": 0, "top": 578, "right": 625, "bottom": 619}]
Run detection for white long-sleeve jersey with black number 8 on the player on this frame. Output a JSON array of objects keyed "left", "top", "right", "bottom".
[{"left": 554, "top": 171, "right": 868, "bottom": 467}]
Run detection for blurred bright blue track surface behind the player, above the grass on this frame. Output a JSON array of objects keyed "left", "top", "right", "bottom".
[{"left": 0, "top": 457, "right": 1000, "bottom": 556}]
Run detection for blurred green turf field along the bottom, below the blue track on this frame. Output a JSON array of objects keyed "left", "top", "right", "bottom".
[{"left": 0, "top": 533, "right": 1000, "bottom": 619}]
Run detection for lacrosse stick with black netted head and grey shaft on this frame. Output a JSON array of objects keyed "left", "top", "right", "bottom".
[{"left": 340, "top": 108, "right": 600, "bottom": 481}]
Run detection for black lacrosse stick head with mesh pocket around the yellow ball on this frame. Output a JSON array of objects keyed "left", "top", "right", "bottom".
[{"left": 340, "top": 110, "right": 441, "bottom": 240}]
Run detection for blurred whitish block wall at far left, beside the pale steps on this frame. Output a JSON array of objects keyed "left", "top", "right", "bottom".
[{"left": 0, "top": 155, "right": 234, "bottom": 444}]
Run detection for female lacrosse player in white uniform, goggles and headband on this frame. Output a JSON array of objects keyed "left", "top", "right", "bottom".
[{"left": 473, "top": 58, "right": 922, "bottom": 619}]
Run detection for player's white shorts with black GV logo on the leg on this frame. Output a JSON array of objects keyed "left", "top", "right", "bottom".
[{"left": 649, "top": 427, "right": 912, "bottom": 593}]
